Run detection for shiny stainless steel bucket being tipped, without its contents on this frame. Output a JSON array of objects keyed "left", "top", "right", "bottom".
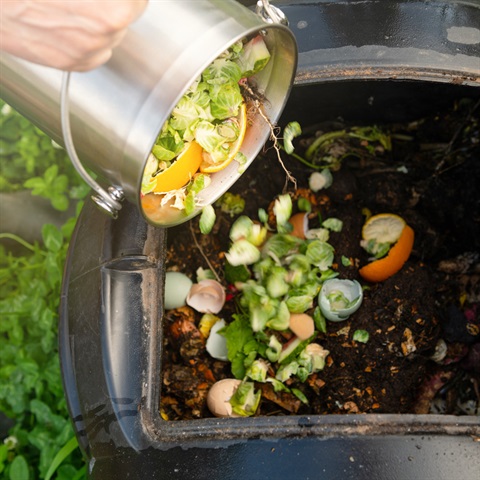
[{"left": 0, "top": 0, "right": 297, "bottom": 226}]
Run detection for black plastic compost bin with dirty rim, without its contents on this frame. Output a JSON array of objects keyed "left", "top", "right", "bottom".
[{"left": 60, "top": 0, "right": 480, "bottom": 480}]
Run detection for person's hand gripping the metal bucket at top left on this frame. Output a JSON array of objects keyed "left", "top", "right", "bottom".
[{"left": 0, "top": 0, "right": 147, "bottom": 71}]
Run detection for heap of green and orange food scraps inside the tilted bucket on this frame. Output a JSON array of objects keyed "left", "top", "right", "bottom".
[{"left": 141, "top": 35, "right": 270, "bottom": 214}]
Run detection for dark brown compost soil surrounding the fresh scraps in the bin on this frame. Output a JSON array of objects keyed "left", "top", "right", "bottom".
[{"left": 160, "top": 100, "right": 480, "bottom": 420}]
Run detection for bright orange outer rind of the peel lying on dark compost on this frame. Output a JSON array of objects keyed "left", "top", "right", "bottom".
[{"left": 359, "top": 225, "right": 415, "bottom": 283}]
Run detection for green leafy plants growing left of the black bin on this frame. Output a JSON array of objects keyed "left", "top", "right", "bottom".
[{"left": 0, "top": 104, "right": 88, "bottom": 480}]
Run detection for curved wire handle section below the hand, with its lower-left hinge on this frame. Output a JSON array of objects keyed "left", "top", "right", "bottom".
[{"left": 60, "top": 72, "right": 124, "bottom": 219}]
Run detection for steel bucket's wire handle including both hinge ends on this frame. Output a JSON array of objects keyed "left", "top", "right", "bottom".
[{"left": 60, "top": 0, "right": 288, "bottom": 219}]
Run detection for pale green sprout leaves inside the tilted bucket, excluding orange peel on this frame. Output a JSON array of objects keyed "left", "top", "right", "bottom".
[{"left": 141, "top": 35, "right": 270, "bottom": 215}]
